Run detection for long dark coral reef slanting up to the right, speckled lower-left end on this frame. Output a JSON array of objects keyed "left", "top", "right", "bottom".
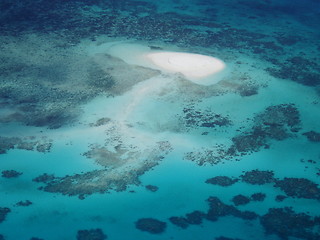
[{"left": 184, "top": 104, "right": 300, "bottom": 165}]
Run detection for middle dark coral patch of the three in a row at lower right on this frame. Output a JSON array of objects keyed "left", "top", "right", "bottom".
[{"left": 240, "top": 169, "right": 275, "bottom": 185}]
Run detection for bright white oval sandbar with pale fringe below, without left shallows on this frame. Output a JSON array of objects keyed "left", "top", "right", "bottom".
[{"left": 146, "top": 52, "right": 226, "bottom": 85}]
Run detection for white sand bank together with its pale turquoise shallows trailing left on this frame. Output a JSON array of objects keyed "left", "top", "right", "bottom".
[{"left": 89, "top": 42, "right": 228, "bottom": 86}]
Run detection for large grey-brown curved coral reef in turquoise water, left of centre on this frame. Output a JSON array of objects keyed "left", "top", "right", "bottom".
[{"left": 33, "top": 141, "right": 172, "bottom": 199}]
